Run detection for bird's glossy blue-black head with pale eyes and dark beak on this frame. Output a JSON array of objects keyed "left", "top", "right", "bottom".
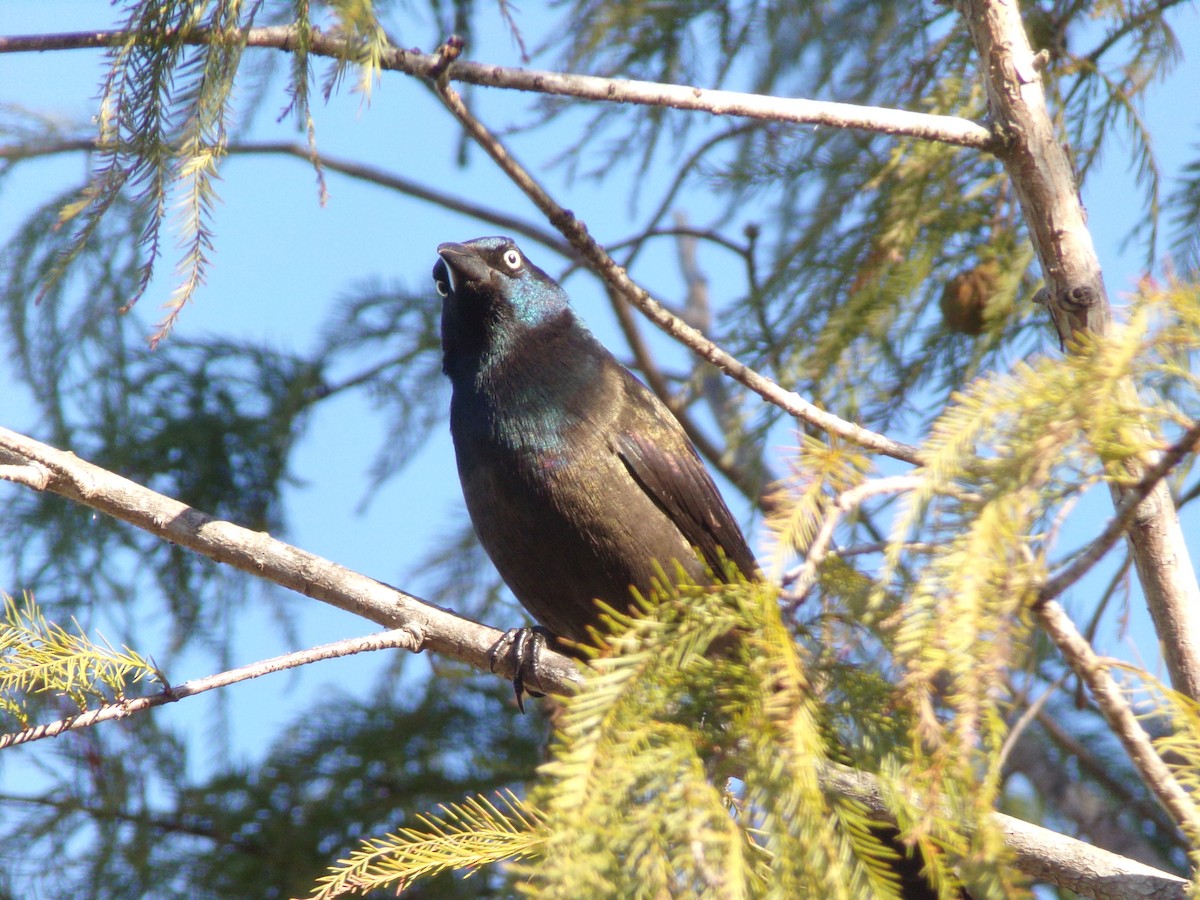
[{"left": 433, "top": 238, "right": 571, "bottom": 374}]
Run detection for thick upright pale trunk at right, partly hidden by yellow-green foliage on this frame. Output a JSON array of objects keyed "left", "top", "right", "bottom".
[{"left": 958, "top": 0, "right": 1200, "bottom": 700}]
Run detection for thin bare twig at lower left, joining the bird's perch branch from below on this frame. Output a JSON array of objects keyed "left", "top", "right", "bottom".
[{"left": 0, "top": 628, "right": 421, "bottom": 750}]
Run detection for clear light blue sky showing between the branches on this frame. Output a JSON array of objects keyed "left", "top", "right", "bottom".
[{"left": 0, "top": 0, "right": 1200, "bottom": 782}]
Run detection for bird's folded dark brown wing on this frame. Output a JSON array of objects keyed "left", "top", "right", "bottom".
[{"left": 616, "top": 409, "right": 757, "bottom": 578}]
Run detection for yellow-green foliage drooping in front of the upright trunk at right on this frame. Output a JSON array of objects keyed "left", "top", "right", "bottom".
[{"left": 876, "top": 283, "right": 1200, "bottom": 897}]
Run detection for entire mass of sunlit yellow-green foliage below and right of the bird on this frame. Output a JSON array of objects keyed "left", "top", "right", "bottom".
[{"left": 312, "top": 288, "right": 1200, "bottom": 898}]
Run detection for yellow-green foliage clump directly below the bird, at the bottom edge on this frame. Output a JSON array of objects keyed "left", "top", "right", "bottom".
[{"left": 319, "top": 583, "right": 974, "bottom": 900}]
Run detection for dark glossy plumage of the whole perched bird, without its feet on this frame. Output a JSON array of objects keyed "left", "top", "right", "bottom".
[{"left": 433, "top": 238, "right": 756, "bottom": 641}]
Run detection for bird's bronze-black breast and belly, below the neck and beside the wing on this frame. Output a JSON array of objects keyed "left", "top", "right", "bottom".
[{"left": 451, "top": 364, "right": 703, "bottom": 640}]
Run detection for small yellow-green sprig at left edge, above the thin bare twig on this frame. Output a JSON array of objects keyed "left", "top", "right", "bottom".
[{"left": 0, "top": 595, "right": 161, "bottom": 726}]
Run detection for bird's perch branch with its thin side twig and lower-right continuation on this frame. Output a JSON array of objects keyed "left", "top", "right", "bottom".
[{"left": 0, "top": 427, "right": 1186, "bottom": 898}]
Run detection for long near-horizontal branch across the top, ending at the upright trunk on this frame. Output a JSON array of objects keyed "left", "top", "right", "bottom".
[{"left": 0, "top": 25, "right": 995, "bottom": 150}]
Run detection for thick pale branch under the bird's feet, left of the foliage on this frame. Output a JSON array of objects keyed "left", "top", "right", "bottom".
[{"left": 0, "top": 427, "right": 580, "bottom": 694}]
